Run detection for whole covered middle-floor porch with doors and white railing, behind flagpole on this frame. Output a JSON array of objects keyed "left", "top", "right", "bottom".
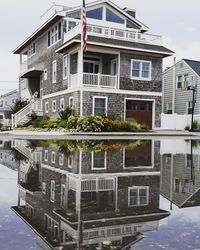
[{"left": 63, "top": 51, "right": 119, "bottom": 89}]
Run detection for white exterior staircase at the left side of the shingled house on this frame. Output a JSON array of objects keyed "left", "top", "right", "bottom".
[{"left": 12, "top": 98, "right": 43, "bottom": 129}]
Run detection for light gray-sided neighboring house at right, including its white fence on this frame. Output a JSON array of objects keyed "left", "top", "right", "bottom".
[{"left": 161, "top": 59, "right": 200, "bottom": 130}]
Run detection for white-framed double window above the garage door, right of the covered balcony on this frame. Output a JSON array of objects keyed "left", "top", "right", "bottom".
[{"left": 131, "top": 59, "right": 151, "bottom": 81}]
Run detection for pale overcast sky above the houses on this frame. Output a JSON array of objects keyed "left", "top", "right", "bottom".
[{"left": 0, "top": 0, "right": 200, "bottom": 94}]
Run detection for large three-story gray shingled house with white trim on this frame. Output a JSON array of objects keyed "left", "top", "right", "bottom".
[{"left": 14, "top": 0, "right": 173, "bottom": 128}]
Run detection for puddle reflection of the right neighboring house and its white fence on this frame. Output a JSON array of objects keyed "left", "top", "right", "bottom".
[{"left": 161, "top": 140, "right": 200, "bottom": 208}]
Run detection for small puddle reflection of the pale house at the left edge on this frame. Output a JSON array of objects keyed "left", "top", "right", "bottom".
[{"left": 0, "top": 140, "right": 18, "bottom": 171}]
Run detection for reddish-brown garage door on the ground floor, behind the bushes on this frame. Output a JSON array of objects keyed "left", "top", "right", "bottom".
[{"left": 126, "top": 100, "right": 153, "bottom": 129}]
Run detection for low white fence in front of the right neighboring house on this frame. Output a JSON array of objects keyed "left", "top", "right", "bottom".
[{"left": 161, "top": 113, "right": 200, "bottom": 130}]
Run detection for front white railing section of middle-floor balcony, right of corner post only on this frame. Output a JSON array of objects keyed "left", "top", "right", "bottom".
[{"left": 83, "top": 73, "right": 117, "bottom": 89}]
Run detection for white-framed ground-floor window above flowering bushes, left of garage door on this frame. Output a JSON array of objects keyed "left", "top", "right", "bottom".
[{"left": 93, "top": 97, "right": 107, "bottom": 115}]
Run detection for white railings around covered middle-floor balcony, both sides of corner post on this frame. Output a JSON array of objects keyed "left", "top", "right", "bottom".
[{"left": 68, "top": 73, "right": 118, "bottom": 89}]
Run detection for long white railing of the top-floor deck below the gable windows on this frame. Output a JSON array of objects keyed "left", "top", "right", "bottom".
[{"left": 64, "top": 22, "right": 162, "bottom": 46}]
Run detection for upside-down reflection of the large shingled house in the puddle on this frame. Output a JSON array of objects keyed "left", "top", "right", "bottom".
[{"left": 13, "top": 141, "right": 169, "bottom": 249}]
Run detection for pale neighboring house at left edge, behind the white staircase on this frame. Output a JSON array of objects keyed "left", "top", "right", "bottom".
[{"left": 0, "top": 90, "right": 19, "bottom": 126}]
